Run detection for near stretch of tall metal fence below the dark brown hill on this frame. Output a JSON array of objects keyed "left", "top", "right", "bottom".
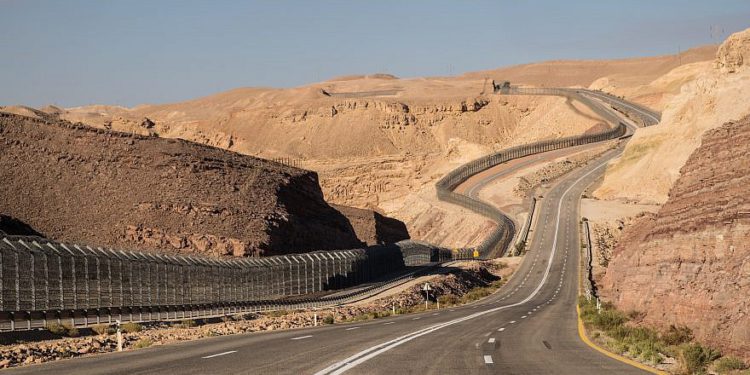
[{"left": 0, "top": 236, "right": 450, "bottom": 330}]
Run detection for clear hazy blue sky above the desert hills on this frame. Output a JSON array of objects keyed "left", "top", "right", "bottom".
[{"left": 0, "top": 0, "right": 750, "bottom": 106}]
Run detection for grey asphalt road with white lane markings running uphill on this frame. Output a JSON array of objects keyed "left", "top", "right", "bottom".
[{"left": 7, "top": 94, "right": 642, "bottom": 375}]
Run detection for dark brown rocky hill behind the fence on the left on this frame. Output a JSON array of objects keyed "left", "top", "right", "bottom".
[{"left": 0, "top": 114, "right": 408, "bottom": 256}]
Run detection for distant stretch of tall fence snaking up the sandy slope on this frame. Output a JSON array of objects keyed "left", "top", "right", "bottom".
[{"left": 435, "top": 86, "right": 629, "bottom": 259}]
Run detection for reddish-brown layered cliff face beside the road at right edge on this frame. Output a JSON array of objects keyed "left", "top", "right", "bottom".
[{"left": 601, "top": 116, "right": 750, "bottom": 359}]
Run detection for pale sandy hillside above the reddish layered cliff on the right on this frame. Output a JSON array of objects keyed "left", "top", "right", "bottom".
[{"left": 594, "top": 29, "right": 750, "bottom": 204}]
